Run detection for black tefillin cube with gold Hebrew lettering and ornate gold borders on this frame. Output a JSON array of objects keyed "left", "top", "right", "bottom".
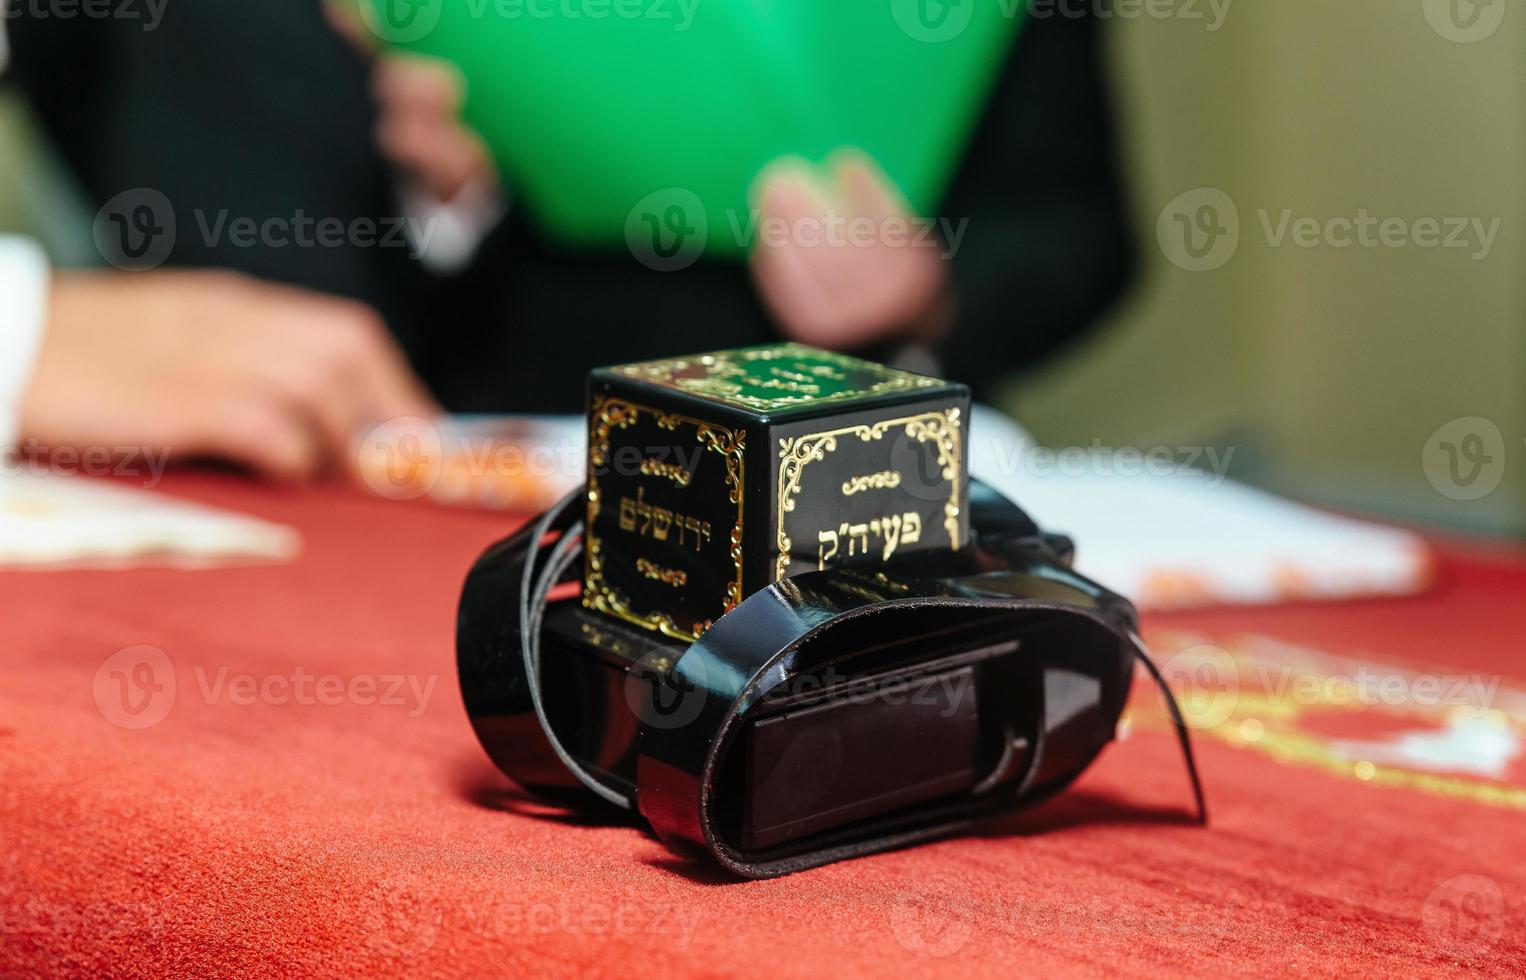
[{"left": 583, "top": 343, "right": 969, "bottom": 641}]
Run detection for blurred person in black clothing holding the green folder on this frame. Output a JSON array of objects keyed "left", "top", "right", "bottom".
[{"left": 0, "top": 0, "right": 1131, "bottom": 412}]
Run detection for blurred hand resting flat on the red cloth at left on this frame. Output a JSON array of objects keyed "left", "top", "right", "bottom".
[{"left": 20, "top": 272, "right": 438, "bottom": 479}]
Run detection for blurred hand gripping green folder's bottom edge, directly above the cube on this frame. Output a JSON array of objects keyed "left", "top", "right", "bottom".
[{"left": 751, "top": 151, "right": 952, "bottom": 350}]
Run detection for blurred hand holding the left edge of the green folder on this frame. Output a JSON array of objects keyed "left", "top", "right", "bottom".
[{"left": 324, "top": 0, "right": 497, "bottom": 201}]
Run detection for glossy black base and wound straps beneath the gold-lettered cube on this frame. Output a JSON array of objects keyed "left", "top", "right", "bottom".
[{"left": 458, "top": 484, "right": 1196, "bottom": 878}]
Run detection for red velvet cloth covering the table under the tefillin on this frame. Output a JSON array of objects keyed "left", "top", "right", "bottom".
[{"left": 0, "top": 475, "right": 1526, "bottom": 977}]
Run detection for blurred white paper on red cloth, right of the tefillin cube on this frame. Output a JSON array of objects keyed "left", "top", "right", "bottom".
[{"left": 971, "top": 406, "right": 1430, "bottom": 609}]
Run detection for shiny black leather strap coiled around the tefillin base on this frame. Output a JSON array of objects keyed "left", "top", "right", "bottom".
[{"left": 458, "top": 484, "right": 1207, "bottom": 878}]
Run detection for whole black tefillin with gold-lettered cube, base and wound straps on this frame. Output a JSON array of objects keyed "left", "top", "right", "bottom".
[{"left": 458, "top": 343, "right": 1202, "bottom": 876}]
